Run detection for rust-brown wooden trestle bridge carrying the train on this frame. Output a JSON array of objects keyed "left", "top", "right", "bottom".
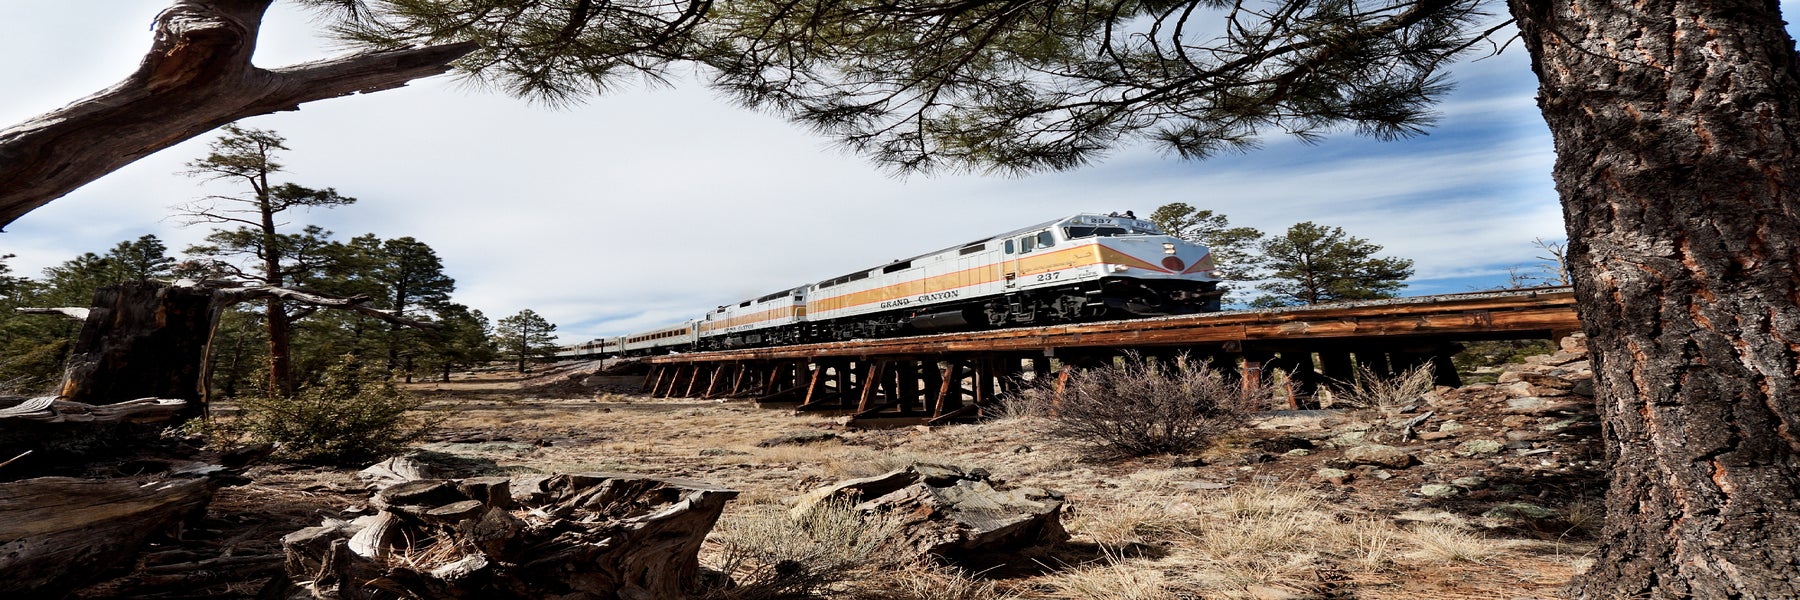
[{"left": 644, "top": 286, "right": 1580, "bottom": 423}]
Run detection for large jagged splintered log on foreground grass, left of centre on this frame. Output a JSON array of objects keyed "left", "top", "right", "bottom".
[{"left": 283, "top": 474, "right": 738, "bottom": 600}]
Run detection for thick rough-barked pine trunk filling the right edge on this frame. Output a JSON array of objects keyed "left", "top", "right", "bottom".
[{"left": 1512, "top": 0, "right": 1800, "bottom": 598}]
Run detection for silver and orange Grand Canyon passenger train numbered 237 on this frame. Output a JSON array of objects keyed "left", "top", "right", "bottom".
[{"left": 556, "top": 213, "right": 1224, "bottom": 359}]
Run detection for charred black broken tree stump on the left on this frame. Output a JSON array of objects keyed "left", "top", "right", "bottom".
[{"left": 61, "top": 281, "right": 212, "bottom": 418}]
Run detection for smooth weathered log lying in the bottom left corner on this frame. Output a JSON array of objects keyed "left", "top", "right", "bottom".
[{"left": 0, "top": 477, "right": 218, "bottom": 598}]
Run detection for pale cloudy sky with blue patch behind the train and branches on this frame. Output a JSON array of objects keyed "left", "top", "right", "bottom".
[{"left": 0, "top": 0, "right": 1591, "bottom": 342}]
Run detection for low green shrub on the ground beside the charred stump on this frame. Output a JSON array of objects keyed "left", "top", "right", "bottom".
[{"left": 238, "top": 357, "right": 437, "bottom": 463}]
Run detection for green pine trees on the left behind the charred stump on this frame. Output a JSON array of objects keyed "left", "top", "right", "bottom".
[{"left": 0, "top": 126, "right": 556, "bottom": 396}]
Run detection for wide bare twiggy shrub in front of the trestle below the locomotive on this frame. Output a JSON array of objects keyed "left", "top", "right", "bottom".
[{"left": 1031, "top": 355, "right": 1274, "bottom": 458}]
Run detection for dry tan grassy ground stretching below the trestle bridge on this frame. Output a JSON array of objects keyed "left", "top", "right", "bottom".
[{"left": 66, "top": 356, "right": 1604, "bottom": 600}]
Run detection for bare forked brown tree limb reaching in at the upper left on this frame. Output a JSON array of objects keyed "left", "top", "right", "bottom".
[{"left": 0, "top": 0, "right": 475, "bottom": 227}]
